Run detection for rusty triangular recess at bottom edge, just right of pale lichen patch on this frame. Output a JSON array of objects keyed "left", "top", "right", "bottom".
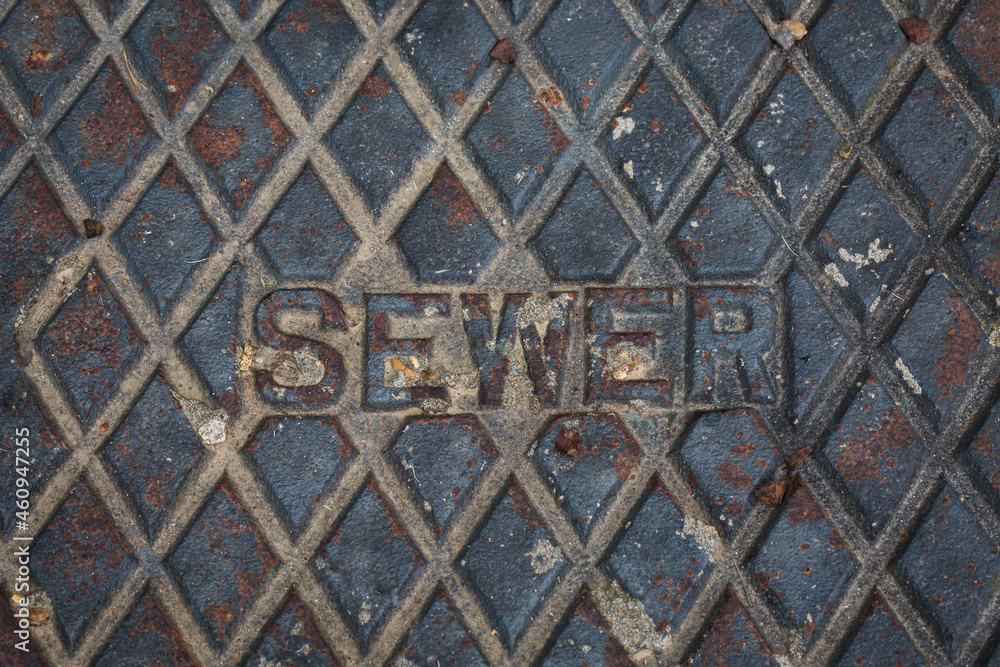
[{"left": 689, "top": 588, "right": 778, "bottom": 667}]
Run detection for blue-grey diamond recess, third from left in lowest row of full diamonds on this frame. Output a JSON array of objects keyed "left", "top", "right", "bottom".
[{"left": 313, "top": 478, "right": 422, "bottom": 644}]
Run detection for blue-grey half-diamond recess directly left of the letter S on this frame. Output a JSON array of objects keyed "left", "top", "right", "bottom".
[{"left": 182, "top": 266, "right": 242, "bottom": 414}]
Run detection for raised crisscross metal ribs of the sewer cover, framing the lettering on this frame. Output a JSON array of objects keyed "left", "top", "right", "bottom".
[{"left": 0, "top": 0, "right": 1000, "bottom": 665}]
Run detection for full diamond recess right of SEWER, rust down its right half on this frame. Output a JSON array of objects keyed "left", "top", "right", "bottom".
[{"left": 892, "top": 271, "right": 986, "bottom": 413}]
